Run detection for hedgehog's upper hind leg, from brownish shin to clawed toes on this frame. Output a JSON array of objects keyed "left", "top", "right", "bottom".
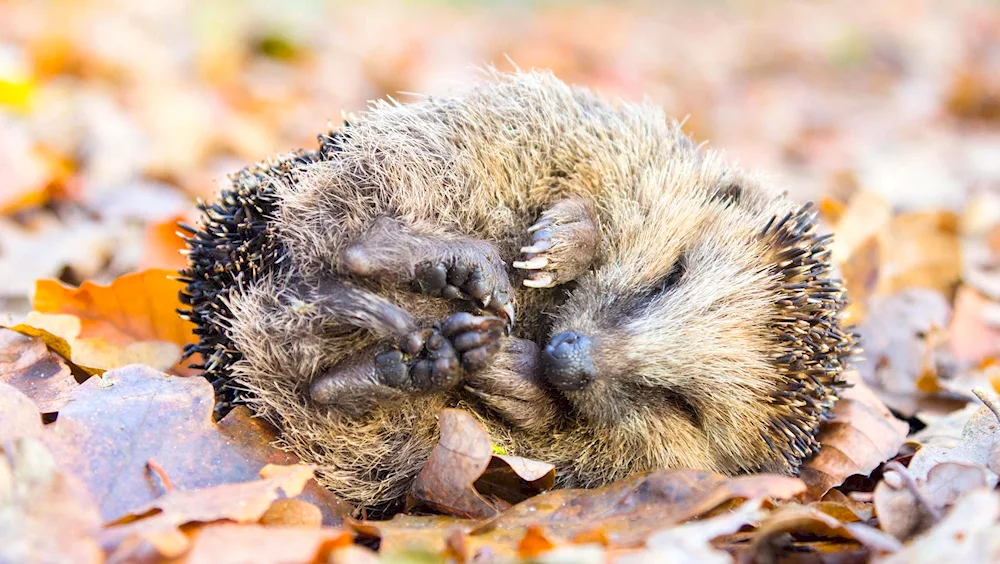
[{"left": 340, "top": 217, "right": 514, "bottom": 323}]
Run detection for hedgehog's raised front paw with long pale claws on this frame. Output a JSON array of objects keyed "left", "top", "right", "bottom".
[{"left": 513, "top": 198, "right": 600, "bottom": 288}]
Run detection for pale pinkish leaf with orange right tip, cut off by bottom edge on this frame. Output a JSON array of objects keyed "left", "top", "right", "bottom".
[{"left": 180, "top": 523, "right": 354, "bottom": 564}]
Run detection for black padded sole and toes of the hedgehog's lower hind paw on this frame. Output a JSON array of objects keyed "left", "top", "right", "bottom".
[{"left": 375, "top": 312, "right": 504, "bottom": 392}]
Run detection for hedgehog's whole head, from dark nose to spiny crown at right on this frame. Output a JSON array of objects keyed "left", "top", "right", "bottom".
[{"left": 543, "top": 186, "right": 853, "bottom": 468}]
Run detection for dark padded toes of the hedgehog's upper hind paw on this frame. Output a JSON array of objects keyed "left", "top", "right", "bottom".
[{"left": 413, "top": 258, "right": 514, "bottom": 323}]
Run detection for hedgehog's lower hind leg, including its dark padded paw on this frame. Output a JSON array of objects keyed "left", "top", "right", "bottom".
[{"left": 309, "top": 312, "right": 503, "bottom": 414}]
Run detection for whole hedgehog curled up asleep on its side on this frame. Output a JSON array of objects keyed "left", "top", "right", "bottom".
[{"left": 176, "top": 72, "right": 856, "bottom": 510}]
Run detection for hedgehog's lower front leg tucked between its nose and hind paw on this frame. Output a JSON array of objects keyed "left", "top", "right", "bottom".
[{"left": 464, "top": 338, "right": 560, "bottom": 432}]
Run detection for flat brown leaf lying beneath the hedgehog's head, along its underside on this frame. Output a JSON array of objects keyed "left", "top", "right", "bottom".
[{"left": 473, "top": 469, "right": 805, "bottom": 547}]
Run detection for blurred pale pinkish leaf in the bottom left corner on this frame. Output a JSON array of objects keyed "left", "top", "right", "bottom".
[{"left": 0, "top": 440, "right": 104, "bottom": 563}]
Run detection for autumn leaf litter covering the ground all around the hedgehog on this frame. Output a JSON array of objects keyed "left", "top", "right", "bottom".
[{"left": 0, "top": 0, "right": 1000, "bottom": 563}]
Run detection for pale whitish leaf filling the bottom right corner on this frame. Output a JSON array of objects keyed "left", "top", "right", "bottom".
[{"left": 876, "top": 488, "right": 1000, "bottom": 564}]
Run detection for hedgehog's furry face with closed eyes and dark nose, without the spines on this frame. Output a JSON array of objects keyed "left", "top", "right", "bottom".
[{"left": 543, "top": 203, "right": 777, "bottom": 432}]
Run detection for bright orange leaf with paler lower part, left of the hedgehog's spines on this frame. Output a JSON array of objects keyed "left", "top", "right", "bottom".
[{"left": 26, "top": 269, "right": 196, "bottom": 370}]
